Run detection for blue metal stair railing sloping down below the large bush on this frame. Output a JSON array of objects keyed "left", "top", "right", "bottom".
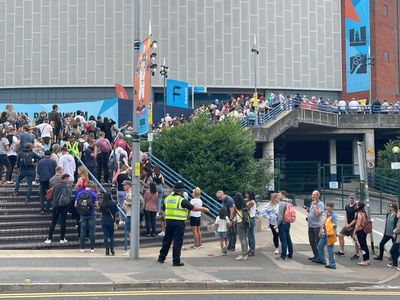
[{"left": 149, "top": 154, "right": 222, "bottom": 218}]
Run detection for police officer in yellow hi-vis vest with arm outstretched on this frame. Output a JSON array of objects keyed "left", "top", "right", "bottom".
[{"left": 158, "top": 181, "right": 209, "bottom": 267}]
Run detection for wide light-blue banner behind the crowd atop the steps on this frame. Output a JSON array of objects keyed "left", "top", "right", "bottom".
[{"left": 0, "top": 98, "right": 118, "bottom": 124}]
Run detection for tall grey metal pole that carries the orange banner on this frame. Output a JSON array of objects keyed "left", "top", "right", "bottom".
[{"left": 129, "top": 0, "right": 140, "bottom": 259}]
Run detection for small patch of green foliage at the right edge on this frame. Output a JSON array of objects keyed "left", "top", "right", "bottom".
[{"left": 376, "top": 139, "right": 400, "bottom": 179}]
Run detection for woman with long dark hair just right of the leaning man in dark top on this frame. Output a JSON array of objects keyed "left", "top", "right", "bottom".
[{"left": 231, "top": 193, "right": 250, "bottom": 260}]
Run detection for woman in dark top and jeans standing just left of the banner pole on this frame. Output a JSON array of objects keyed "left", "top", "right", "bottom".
[{"left": 100, "top": 193, "right": 118, "bottom": 256}]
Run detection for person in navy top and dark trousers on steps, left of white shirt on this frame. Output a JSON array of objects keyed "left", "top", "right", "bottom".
[{"left": 36, "top": 150, "right": 57, "bottom": 215}]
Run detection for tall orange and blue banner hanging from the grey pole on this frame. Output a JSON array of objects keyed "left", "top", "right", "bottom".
[{"left": 134, "top": 37, "right": 151, "bottom": 134}]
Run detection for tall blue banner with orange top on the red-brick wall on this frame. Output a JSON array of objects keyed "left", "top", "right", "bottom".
[{"left": 345, "top": 0, "right": 370, "bottom": 93}]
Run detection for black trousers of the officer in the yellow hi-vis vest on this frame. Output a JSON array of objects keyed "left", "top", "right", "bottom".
[{"left": 158, "top": 220, "right": 185, "bottom": 264}]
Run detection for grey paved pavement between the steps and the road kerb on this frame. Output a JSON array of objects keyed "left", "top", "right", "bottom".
[{"left": 0, "top": 209, "right": 400, "bottom": 293}]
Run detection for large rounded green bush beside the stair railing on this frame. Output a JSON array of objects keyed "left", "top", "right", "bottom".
[{"left": 153, "top": 115, "right": 272, "bottom": 196}]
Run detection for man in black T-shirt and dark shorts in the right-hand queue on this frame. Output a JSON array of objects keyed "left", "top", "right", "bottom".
[{"left": 335, "top": 193, "right": 360, "bottom": 260}]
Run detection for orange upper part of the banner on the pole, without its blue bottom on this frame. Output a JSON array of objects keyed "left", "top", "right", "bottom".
[{"left": 134, "top": 37, "right": 151, "bottom": 115}]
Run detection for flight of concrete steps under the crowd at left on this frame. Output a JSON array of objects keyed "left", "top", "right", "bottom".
[{"left": 0, "top": 185, "right": 215, "bottom": 249}]
